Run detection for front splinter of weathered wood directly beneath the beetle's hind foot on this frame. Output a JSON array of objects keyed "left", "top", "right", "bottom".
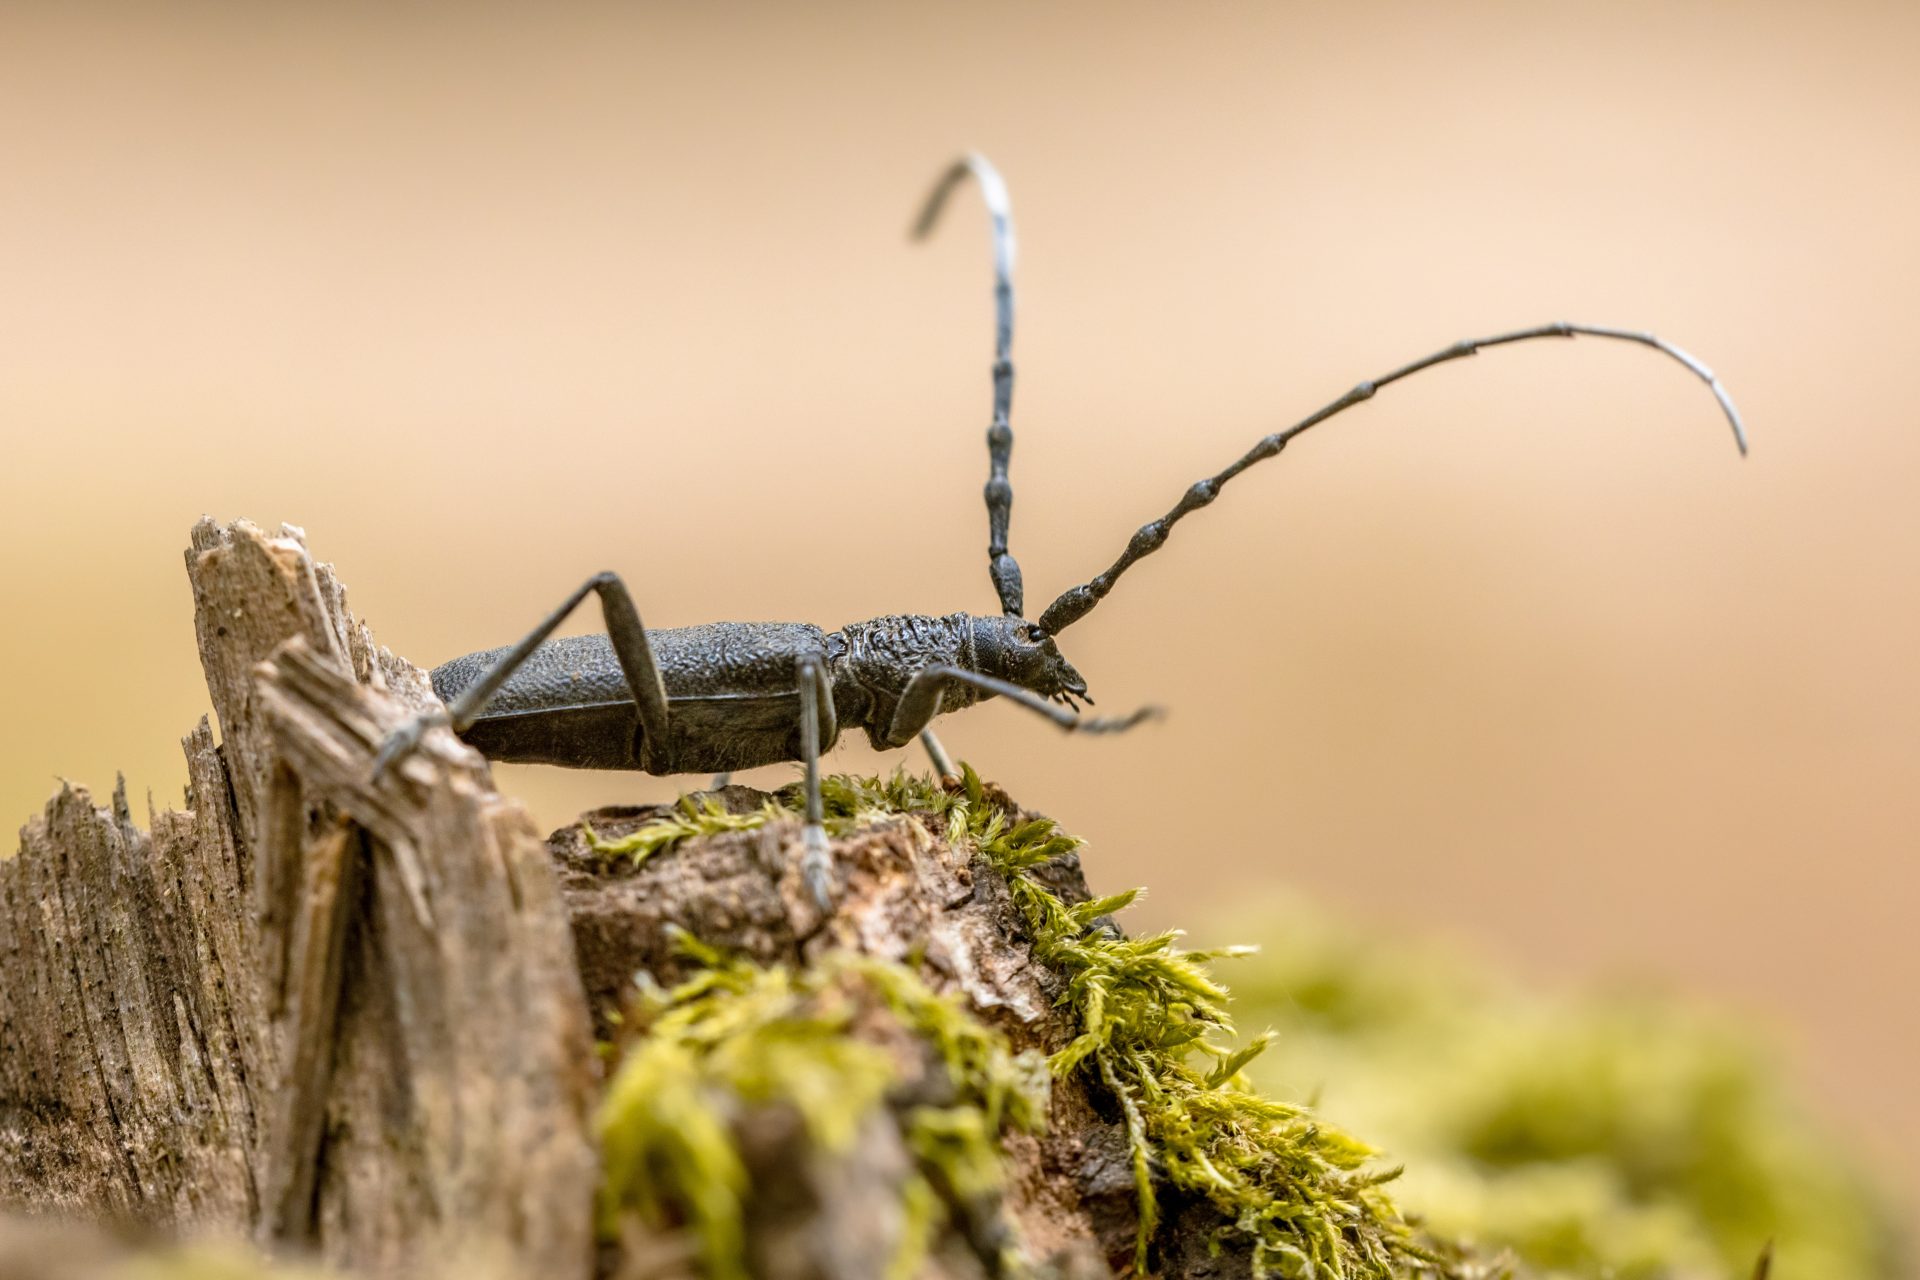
[{"left": 257, "top": 643, "right": 593, "bottom": 1274}]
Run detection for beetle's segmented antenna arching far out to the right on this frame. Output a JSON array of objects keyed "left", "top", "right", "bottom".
[{"left": 1041, "top": 322, "right": 1747, "bottom": 635}]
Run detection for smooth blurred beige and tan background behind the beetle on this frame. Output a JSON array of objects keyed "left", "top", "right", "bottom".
[{"left": 0, "top": 2, "right": 1920, "bottom": 1243}]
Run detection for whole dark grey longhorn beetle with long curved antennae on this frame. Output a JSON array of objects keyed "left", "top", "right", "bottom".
[{"left": 374, "top": 155, "right": 1747, "bottom": 910}]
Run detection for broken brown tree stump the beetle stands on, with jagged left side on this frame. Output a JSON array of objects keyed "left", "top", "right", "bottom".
[{"left": 0, "top": 520, "right": 1451, "bottom": 1280}]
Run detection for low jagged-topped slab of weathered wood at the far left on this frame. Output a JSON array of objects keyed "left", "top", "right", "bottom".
[{"left": 0, "top": 771, "right": 253, "bottom": 1230}]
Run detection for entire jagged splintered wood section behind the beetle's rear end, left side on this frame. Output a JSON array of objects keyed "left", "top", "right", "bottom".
[{"left": 0, "top": 520, "right": 595, "bottom": 1276}]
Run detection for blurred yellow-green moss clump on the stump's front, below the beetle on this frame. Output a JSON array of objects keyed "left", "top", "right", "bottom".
[{"left": 595, "top": 936, "right": 1046, "bottom": 1280}]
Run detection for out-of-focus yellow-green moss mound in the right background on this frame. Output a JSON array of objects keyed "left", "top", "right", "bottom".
[{"left": 1236, "top": 904, "right": 1903, "bottom": 1280}]
